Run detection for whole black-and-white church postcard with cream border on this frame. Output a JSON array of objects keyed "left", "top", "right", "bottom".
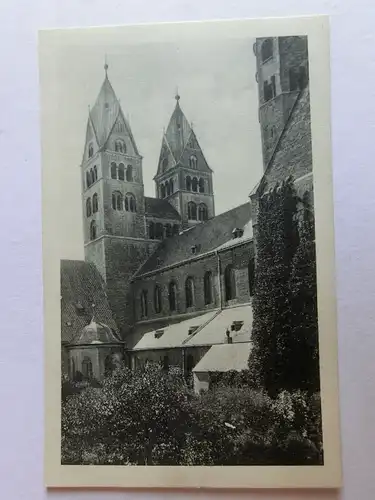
[{"left": 39, "top": 17, "right": 341, "bottom": 488}]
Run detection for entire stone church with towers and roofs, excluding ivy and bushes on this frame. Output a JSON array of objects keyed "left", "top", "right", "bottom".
[{"left": 61, "top": 37, "right": 312, "bottom": 387}]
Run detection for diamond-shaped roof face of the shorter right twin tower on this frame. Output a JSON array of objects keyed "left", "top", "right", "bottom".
[{"left": 164, "top": 95, "right": 192, "bottom": 162}]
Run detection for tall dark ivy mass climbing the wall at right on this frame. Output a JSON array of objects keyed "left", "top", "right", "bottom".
[{"left": 249, "top": 178, "right": 319, "bottom": 396}]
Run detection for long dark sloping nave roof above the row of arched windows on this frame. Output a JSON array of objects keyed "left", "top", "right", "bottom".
[{"left": 135, "top": 202, "right": 251, "bottom": 276}]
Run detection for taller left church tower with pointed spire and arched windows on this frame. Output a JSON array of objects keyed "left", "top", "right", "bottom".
[{"left": 81, "top": 65, "right": 159, "bottom": 333}]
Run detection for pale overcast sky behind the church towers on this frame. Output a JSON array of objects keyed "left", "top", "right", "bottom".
[{"left": 50, "top": 38, "right": 262, "bottom": 258}]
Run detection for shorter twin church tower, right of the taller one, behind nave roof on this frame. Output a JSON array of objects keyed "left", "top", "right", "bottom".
[{"left": 154, "top": 93, "right": 215, "bottom": 229}]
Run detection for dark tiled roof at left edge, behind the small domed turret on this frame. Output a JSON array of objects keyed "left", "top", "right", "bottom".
[{"left": 60, "top": 260, "right": 118, "bottom": 342}]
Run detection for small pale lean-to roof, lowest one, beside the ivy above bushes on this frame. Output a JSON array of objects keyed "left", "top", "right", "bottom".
[{"left": 193, "top": 342, "right": 251, "bottom": 372}]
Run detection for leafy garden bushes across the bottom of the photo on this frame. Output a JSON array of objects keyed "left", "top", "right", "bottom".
[{"left": 61, "top": 365, "right": 322, "bottom": 465}]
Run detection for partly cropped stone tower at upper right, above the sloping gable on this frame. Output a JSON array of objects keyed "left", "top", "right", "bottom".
[{"left": 254, "top": 36, "right": 308, "bottom": 169}]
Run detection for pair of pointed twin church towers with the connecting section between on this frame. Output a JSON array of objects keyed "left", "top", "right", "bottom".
[{"left": 81, "top": 65, "right": 215, "bottom": 334}]
